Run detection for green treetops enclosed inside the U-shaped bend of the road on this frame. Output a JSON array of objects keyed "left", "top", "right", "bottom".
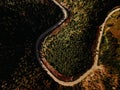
[{"left": 42, "top": 0, "right": 119, "bottom": 76}]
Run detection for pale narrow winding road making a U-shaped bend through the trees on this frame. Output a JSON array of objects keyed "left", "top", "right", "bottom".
[{"left": 36, "top": 0, "right": 120, "bottom": 86}]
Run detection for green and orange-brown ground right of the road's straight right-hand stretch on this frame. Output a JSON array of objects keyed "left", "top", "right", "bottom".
[{"left": 100, "top": 8, "right": 120, "bottom": 72}]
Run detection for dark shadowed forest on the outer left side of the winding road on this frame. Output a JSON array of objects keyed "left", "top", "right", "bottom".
[{"left": 0, "top": 0, "right": 62, "bottom": 90}]
